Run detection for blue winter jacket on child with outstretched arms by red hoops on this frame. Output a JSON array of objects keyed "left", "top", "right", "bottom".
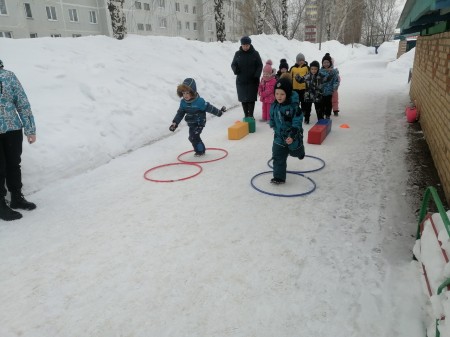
[{"left": 173, "top": 94, "right": 222, "bottom": 127}]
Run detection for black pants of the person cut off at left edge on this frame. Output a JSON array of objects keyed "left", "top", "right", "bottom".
[{"left": 0, "top": 130, "right": 23, "bottom": 198}]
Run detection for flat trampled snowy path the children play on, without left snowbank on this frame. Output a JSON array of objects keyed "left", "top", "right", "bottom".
[{"left": 0, "top": 56, "right": 424, "bottom": 337}]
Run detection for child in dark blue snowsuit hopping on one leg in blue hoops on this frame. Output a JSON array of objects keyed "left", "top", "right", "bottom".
[{"left": 270, "top": 78, "right": 305, "bottom": 184}]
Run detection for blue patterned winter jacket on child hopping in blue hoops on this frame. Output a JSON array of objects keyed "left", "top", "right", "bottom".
[{"left": 270, "top": 91, "right": 303, "bottom": 149}]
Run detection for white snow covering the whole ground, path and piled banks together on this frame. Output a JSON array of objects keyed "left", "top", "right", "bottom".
[{"left": 0, "top": 35, "right": 442, "bottom": 337}]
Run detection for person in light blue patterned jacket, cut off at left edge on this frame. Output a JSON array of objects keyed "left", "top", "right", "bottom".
[{"left": 0, "top": 60, "right": 36, "bottom": 221}]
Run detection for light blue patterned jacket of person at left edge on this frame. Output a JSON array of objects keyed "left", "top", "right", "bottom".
[{"left": 0, "top": 68, "right": 36, "bottom": 136}]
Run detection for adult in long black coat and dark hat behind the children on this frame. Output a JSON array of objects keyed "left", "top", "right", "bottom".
[{"left": 231, "top": 36, "right": 263, "bottom": 117}]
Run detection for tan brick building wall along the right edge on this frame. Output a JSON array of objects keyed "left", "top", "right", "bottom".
[{"left": 410, "top": 32, "right": 450, "bottom": 203}]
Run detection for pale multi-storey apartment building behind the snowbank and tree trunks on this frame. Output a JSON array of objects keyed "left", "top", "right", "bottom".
[{"left": 0, "top": 0, "right": 242, "bottom": 42}]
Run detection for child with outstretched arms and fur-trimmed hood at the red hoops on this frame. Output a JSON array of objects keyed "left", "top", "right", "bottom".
[{"left": 169, "top": 78, "right": 226, "bottom": 157}]
